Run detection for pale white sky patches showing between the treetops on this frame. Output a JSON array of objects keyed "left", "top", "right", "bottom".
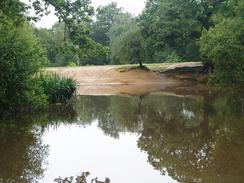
[{"left": 21, "top": 0, "right": 146, "bottom": 28}]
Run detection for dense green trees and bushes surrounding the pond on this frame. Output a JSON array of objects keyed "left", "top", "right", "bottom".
[{"left": 0, "top": 0, "right": 244, "bottom": 114}]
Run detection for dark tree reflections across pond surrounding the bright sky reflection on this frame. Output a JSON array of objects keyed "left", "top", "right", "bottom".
[{"left": 0, "top": 93, "right": 244, "bottom": 183}]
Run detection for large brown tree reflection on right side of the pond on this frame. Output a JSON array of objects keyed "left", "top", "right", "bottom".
[{"left": 138, "top": 93, "right": 244, "bottom": 183}]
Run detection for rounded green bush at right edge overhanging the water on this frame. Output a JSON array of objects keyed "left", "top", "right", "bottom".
[{"left": 200, "top": 18, "right": 244, "bottom": 86}]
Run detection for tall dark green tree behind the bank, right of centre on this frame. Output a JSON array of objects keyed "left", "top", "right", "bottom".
[{"left": 139, "top": 0, "right": 202, "bottom": 62}]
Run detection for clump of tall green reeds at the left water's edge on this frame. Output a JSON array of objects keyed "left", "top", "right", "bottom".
[{"left": 36, "top": 73, "right": 77, "bottom": 103}]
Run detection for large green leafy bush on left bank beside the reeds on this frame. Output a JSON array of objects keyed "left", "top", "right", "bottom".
[{"left": 0, "top": 11, "right": 46, "bottom": 112}]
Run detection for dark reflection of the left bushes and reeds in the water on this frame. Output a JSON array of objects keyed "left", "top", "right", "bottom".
[{"left": 0, "top": 106, "right": 77, "bottom": 183}]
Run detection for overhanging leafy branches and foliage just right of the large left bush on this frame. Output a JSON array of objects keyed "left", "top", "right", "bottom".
[{"left": 34, "top": 0, "right": 106, "bottom": 66}]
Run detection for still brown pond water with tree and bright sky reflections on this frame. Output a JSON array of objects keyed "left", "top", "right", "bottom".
[{"left": 0, "top": 93, "right": 244, "bottom": 183}]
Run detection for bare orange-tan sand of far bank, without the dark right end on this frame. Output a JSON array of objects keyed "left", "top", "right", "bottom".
[{"left": 47, "top": 63, "right": 203, "bottom": 95}]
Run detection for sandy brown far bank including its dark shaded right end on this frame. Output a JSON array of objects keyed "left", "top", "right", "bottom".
[{"left": 47, "top": 65, "right": 208, "bottom": 95}]
